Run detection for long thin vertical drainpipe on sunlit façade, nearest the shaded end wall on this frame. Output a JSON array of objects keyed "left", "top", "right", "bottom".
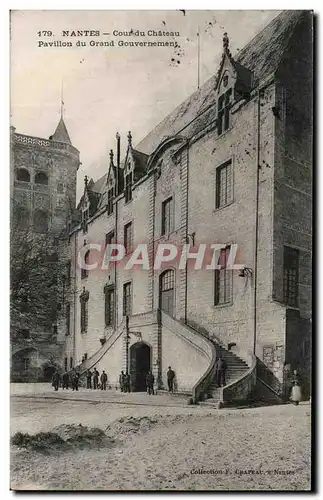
[{"left": 253, "top": 89, "right": 263, "bottom": 354}]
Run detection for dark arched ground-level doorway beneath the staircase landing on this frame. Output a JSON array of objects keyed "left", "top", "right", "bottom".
[{"left": 130, "top": 342, "right": 151, "bottom": 392}]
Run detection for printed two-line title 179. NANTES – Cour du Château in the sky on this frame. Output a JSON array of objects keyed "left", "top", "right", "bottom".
[{"left": 37, "top": 29, "right": 180, "bottom": 48}]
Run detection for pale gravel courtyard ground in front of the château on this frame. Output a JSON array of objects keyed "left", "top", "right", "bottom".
[{"left": 11, "top": 384, "right": 311, "bottom": 491}]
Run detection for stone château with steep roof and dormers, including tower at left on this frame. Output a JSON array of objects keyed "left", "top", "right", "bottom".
[{"left": 10, "top": 11, "right": 313, "bottom": 401}]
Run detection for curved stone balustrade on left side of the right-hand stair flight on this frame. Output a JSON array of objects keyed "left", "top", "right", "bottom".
[{"left": 161, "top": 311, "right": 216, "bottom": 401}]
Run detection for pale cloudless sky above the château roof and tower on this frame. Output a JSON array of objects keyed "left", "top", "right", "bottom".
[{"left": 11, "top": 10, "right": 280, "bottom": 196}]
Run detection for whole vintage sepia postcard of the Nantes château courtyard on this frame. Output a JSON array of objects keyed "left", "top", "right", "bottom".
[{"left": 10, "top": 9, "right": 314, "bottom": 492}]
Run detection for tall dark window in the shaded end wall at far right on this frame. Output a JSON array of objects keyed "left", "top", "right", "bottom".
[{"left": 283, "top": 247, "right": 299, "bottom": 307}]
